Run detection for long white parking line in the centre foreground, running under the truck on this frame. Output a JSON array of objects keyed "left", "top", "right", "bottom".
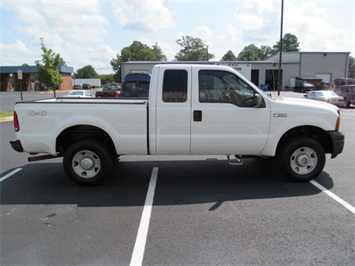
[{"left": 130, "top": 167, "right": 159, "bottom": 265}]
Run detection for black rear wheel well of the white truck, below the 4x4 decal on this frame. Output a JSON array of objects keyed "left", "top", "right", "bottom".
[{"left": 56, "top": 125, "right": 116, "bottom": 155}]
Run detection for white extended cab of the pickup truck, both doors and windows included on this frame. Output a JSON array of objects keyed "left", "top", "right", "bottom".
[{"left": 149, "top": 65, "right": 270, "bottom": 154}]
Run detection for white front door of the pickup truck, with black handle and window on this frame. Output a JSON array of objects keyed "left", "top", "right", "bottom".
[{"left": 191, "top": 66, "right": 270, "bottom": 155}]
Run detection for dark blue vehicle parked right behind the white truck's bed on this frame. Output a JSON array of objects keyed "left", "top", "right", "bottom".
[{"left": 121, "top": 73, "right": 151, "bottom": 98}]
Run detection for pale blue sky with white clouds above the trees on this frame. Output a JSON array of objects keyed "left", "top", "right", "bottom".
[{"left": 0, "top": 0, "right": 355, "bottom": 74}]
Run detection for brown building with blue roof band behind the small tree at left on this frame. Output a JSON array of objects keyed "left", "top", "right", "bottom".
[{"left": 0, "top": 66, "right": 74, "bottom": 91}]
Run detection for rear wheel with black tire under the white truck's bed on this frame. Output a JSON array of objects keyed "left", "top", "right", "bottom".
[{"left": 63, "top": 140, "right": 113, "bottom": 186}]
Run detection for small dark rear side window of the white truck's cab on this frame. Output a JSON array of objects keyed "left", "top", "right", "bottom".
[{"left": 163, "top": 70, "right": 187, "bottom": 102}]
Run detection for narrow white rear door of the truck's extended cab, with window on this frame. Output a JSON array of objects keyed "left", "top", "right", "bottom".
[{"left": 150, "top": 65, "right": 191, "bottom": 155}]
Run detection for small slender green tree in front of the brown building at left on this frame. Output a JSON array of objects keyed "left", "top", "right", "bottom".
[{"left": 36, "top": 41, "right": 63, "bottom": 97}]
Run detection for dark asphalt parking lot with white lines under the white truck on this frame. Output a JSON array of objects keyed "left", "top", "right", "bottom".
[{"left": 0, "top": 91, "right": 355, "bottom": 265}]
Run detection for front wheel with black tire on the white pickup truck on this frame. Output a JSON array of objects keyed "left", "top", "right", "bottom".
[{"left": 278, "top": 137, "right": 325, "bottom": 182}]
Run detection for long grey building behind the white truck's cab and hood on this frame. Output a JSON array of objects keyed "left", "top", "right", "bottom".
[{"left": 121, "top": 52, "right": 350, "bottom": 90}]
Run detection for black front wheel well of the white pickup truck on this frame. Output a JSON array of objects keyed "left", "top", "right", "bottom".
[{"left": 276, "top": 126, "right": 333, "bottom": 156}]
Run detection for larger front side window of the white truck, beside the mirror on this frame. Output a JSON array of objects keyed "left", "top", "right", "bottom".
[{"left": 199, "top": 70, "right": 257, "bottom": 107}]
